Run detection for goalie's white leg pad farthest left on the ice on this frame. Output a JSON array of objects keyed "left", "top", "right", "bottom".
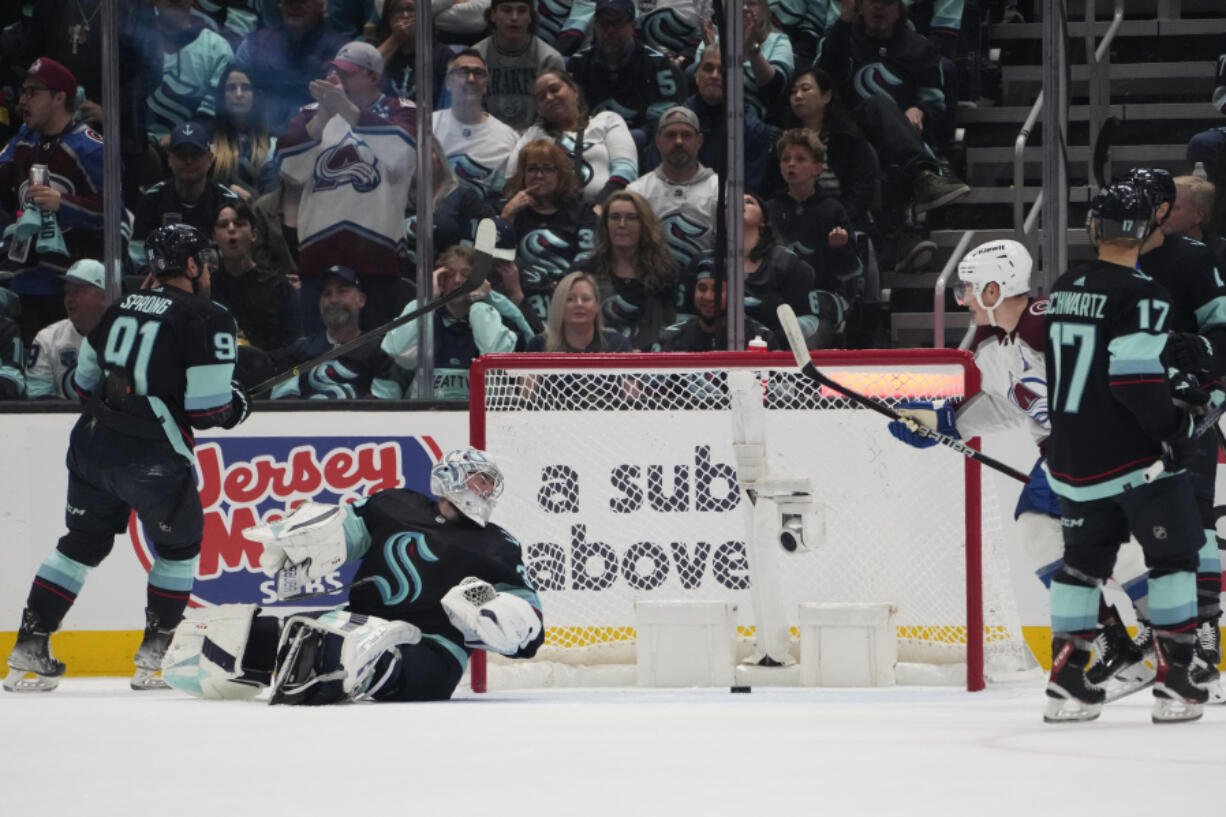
[{"left": 162, "top": 605, "right": 268, "bottom": 700}]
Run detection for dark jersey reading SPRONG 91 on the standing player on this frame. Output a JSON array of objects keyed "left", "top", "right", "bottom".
[{"left": 74, "top": 287, "right": 238, "bottom": 451}]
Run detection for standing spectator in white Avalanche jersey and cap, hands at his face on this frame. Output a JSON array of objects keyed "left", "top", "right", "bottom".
[{"left": 277, "top": 43, "right": 417, "bottom": 335}]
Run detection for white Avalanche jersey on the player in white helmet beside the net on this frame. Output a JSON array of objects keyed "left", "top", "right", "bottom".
[{"left": 958, "top": 298, "right": 1052, "bottom": 445}]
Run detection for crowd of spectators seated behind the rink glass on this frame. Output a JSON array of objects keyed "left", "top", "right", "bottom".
[{"left": 0, "top": 0, "right": 1137, "bottom": 397}]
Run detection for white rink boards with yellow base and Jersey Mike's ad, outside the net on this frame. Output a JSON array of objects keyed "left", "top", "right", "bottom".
[{"left": 0, "top": 411, "right": 1226, "bottom": 675}]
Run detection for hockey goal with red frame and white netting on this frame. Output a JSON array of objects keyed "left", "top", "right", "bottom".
[{"left": 470, "top": 350, "right": 1030, "bottom": 691}]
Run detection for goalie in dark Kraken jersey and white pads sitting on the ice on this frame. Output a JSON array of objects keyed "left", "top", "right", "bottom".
[{"left": 164, "top": 448, "right": 544, "bottom": 705}]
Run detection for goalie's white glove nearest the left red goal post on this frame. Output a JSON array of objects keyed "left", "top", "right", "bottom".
[{"left": 443, "top": 577, "right": 541, "bottom": 656}]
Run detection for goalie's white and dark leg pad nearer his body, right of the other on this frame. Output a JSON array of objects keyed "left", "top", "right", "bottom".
[{"left": 270, "top": 610, "right": 422, "bottom": 705}]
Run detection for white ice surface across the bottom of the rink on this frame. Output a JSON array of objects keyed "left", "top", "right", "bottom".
[{"left": 0, "top": 678, "right": 1226, "bottom": 817}]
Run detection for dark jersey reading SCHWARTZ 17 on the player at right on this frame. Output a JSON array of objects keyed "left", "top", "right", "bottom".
[{"left": 1046, "top": 261, "right": 1178, "bottom": 502}]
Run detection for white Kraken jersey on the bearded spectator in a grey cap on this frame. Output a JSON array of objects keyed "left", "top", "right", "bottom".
[{"left": 626, "top": 166, "right": 720, "bottom": 270}]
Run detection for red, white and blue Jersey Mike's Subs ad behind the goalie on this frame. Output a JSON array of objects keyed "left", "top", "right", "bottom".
[{"left": 128, "top": 437, "right": 443, "bottom": 607}]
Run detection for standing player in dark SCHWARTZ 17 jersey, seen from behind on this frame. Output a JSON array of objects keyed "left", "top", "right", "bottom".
[{"left": 1043, "top": 183, "right": 1209, "bottom": 723}]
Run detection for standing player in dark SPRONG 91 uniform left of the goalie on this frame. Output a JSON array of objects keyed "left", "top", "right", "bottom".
[{"left": 4, "top": 224, "right": 249, "bottom": 691}]
